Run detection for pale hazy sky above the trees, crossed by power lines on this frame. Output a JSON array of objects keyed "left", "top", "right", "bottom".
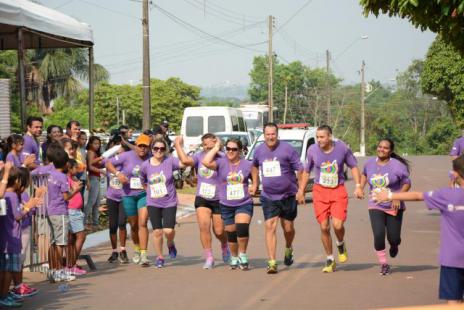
[{"left": 39, "top": 0, "right": 435, "bottom": 86}]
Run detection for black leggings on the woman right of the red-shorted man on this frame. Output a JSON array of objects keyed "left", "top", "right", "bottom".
[{"left": 369, "top": 209, "right": 403, "bottom": 251}]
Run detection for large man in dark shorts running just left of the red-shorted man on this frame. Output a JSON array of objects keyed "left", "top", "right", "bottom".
[{"left": 250, "top": 123, "right": 303, "bottom": 274}]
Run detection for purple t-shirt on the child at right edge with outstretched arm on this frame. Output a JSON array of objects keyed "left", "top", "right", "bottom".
[{"left": 424, "top": 187, "right": 464, "bottom": 268}]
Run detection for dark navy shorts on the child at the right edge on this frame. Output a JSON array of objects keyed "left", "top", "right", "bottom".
[{"left": 439, "top": 266, "right": 464, "bottom": 300}]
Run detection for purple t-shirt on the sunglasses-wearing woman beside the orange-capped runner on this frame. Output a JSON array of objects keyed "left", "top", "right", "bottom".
[{"left": 140, "top": 156, "right": 179, "bottom": 208}]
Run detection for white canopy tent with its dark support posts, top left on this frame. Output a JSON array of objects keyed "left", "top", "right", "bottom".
[{"left": 0, "top": 0, "right": 94, "bottom": 129}]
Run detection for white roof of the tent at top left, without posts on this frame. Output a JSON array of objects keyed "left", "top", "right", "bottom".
[{"left": 0, "top": 0, "right": 93, "bottom": 50}]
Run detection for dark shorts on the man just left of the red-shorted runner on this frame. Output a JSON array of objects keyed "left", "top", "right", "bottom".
[{"left": 259, "top": 195, "right": 298, "bottom": 221}]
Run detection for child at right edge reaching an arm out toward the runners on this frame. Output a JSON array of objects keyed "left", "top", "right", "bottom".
[{"left": 374, "top": 155, "right": 464, "bottom": 303}]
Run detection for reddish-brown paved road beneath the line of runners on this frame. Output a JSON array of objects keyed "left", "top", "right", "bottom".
[{"left": 23, "top": 156, "right": 450, "bottom": 309}]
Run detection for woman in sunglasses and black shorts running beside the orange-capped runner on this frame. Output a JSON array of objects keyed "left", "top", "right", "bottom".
[{"left": 140, "top": 138, "right": 180, "bottom": 268}]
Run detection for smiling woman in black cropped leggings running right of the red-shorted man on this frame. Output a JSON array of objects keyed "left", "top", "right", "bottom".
[{"left": 361, "top": 139, "right": 411, "bottom": 275}]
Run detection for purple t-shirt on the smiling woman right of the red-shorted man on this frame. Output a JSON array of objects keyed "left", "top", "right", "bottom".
[{"left": 363, "top": 158, "right": 411, "bottom": 211}]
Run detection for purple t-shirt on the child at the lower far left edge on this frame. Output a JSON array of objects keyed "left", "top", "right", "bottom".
[{"left": 0, "top": 192, "right": 22, "bottom": 254}]
